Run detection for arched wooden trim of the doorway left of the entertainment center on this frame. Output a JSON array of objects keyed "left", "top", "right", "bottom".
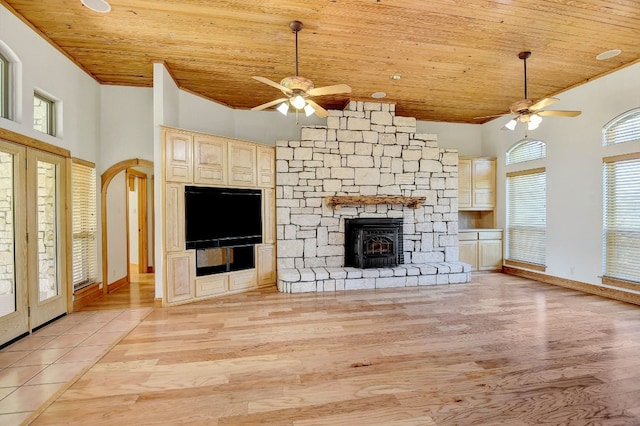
[{"left": 100, "top": 158, "right": 153, "bottom": 294}]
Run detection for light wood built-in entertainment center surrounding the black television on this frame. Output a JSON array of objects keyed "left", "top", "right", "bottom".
[{"left": 161, "top": 127, "right": 276, "bottom": 306}]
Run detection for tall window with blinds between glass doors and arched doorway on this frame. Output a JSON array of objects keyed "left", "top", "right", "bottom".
[{"left": 71, "top": 158, "right": 98, "bottom": 291}]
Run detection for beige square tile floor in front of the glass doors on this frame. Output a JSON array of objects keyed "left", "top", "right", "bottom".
[{"left": 0, "top": 308, "right": 152, "bottom": 426}]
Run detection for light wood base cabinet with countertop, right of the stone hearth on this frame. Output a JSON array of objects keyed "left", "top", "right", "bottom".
[{"left": 458, "top": 229, "right": 502, "bottom": 271}]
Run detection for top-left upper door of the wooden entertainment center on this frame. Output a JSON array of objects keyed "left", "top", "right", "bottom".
[{"left": 164, "top": 131, "right": 193, "bottom": 183}]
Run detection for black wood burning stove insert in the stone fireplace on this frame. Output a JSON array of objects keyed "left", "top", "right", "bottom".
[{"left": 344, "top": 218, "right": 404, "bottom": 268}]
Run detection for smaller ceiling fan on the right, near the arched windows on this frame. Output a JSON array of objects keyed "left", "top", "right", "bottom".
[{"left": 476, "top": 52, "right": 581, "bottom": 130}]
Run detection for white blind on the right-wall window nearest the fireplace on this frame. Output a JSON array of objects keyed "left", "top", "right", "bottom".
[{"left": 507, "top": 169, "right": 547, "bottom": 265}]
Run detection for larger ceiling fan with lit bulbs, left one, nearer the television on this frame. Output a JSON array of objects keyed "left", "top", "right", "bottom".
[{"left": 251, "top": 21, "right": 351, "bottom": 117}]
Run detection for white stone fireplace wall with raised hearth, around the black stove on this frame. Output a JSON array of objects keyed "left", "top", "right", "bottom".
[{"left": 276, "top": 102, "right": 469, "bottom": 292}]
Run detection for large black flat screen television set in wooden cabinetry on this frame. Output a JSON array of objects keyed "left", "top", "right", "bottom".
[{"left": 184, "top": 186, "right": 262, "bottom": 249}]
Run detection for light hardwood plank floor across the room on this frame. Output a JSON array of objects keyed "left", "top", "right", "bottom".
[{"left": 33, "top": 274, "right": 640, "bottom": 426}]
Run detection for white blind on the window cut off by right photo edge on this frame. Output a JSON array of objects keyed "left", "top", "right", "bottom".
[{"left": 602, "top": 154, "right": 640, "bottom": 283}]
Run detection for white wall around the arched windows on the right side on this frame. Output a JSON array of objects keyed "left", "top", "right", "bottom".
[{"left": 482, "top": 64, "right": 640, "bottom": 284}]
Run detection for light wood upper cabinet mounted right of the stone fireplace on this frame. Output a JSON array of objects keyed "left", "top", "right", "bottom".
[{"left": 458, "top": 157, "right": 496, "bottom": 210}]
